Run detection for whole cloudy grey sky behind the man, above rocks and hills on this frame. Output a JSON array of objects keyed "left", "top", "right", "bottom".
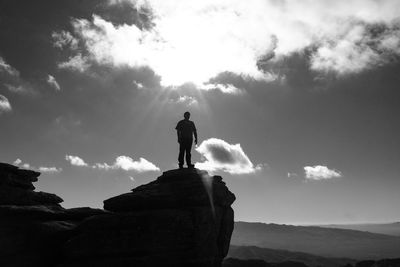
[{"left": 0, "top": 0, "right": 400, "bottom": 224}]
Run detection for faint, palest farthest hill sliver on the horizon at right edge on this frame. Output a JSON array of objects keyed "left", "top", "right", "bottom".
[{"left": 317, "top": 222, "right": 400, "bottom": 236}]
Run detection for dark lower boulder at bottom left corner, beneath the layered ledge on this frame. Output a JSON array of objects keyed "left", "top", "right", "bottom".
[{"left": 0, "top": 205, "right": 107, "bottom": 267}]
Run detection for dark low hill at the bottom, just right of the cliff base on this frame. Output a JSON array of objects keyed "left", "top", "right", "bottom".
[{"left": 228, "top": 246, "right": 356, "bottom": 267}]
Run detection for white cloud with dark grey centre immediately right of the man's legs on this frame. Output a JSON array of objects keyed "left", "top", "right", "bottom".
[{"left": 196, "top": 138, "right": 261, "bottom": 174}]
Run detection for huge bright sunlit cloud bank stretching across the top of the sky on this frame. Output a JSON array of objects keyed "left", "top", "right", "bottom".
[{"left": 65, "top": 0, "right": 400, "bottom": 89}]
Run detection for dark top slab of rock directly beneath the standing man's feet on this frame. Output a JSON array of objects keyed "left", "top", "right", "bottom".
[{"left": 104, "top": 169, "right": 235, "bottom": 212}]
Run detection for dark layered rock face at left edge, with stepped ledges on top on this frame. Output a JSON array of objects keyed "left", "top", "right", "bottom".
[{"left": 0, "top": 163, "right": 105, "bottom": 267}]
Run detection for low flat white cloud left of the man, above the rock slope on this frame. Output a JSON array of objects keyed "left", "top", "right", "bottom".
[{"left": 93, "top": 156, "right": 160, "bottom": 172}]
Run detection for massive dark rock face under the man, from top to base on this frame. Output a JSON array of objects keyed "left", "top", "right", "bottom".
[{"left": 61, "top": 169, "right": 235, "bottom": 267}]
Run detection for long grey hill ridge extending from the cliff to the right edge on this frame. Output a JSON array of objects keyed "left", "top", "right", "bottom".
[{"left": 231, "top": 222, "right": 400, "bottom": 260}]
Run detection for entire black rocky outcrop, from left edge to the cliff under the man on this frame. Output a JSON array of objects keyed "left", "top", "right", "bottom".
[{"left": 0, "top": 163, "right": 235, "bottom": 267}]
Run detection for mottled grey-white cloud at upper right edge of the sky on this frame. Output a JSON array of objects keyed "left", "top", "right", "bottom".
[{"left": 311, "top": 23, "right": 400, "bottom": 75}]
